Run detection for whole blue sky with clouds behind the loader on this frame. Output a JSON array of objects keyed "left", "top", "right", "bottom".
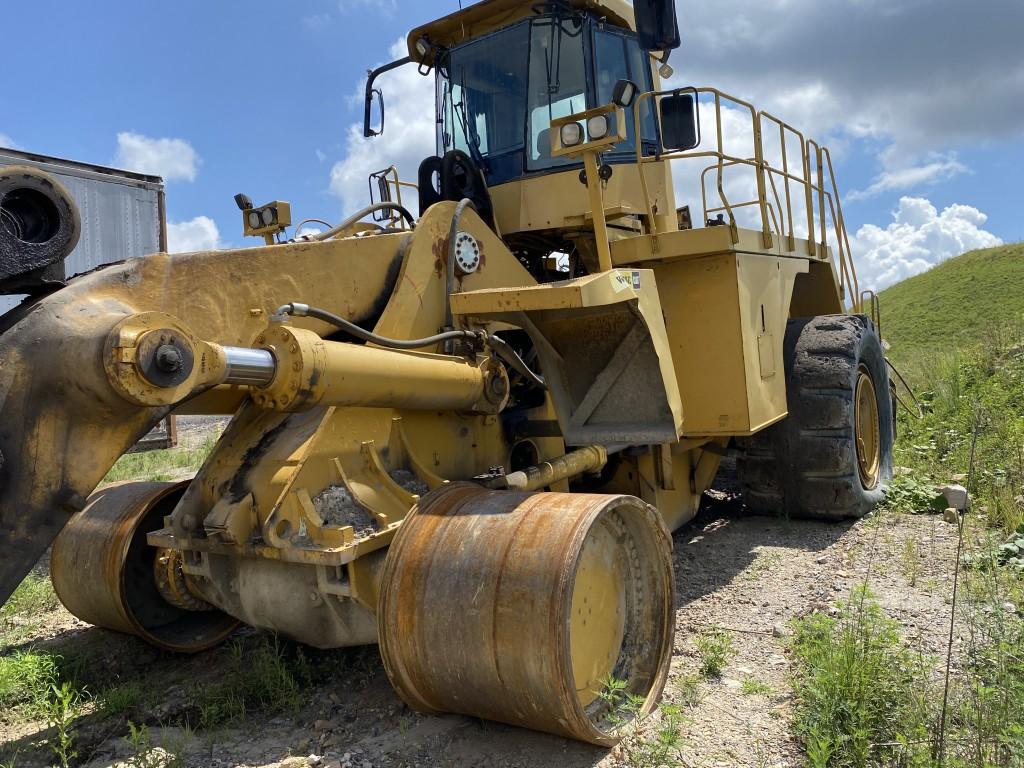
[{"left": 0, "top": 0, "right": 1024, "bottom": 285}]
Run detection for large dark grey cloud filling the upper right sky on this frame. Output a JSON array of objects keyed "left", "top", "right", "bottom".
[{"left": 673, "top": 0, "right": 1024, "bottom": 154}]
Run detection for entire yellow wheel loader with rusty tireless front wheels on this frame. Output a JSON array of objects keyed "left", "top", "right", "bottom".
[{"left": 0, "top": 0, "right": 893, "bottom": 744}]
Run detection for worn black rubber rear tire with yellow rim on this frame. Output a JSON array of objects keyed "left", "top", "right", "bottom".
[{"left": 737, "top": 314, "right": 894, "bottom": 520}]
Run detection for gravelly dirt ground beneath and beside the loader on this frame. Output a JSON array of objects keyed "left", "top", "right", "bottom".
[{"left": 0, "top": 468, "right": 955, "bottom": 768}]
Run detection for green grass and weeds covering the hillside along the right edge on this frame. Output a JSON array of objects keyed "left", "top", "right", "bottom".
[{"left": 792, "top": 245, "right": 1024, "bottom": 768}]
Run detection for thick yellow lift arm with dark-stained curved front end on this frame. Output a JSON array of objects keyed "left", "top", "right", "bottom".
[{"left": 0, "top": 234, "right": 408, "bottom": 602}]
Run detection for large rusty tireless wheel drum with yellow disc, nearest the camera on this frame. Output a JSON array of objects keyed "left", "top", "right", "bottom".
[{"left": 378, "top": 483, "right": 674, "bottom": 745}]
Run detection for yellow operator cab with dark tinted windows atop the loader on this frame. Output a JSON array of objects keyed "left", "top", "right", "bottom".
[{"left": 365, "top": 0, "right": 678, "bottom": 279}]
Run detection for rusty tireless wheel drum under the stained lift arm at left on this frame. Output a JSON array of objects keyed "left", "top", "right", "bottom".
[{"left": 50, "top": 481, "right": 239, "bottom": 652}]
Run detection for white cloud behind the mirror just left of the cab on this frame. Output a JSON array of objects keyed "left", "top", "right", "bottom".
[{"left": 331, "top": 39, "right": 436, "bottom": 215}]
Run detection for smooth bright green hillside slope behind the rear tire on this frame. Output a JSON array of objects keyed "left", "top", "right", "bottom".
[{"left": 880, "top": 243, "right": 1024, "bottom": 359}]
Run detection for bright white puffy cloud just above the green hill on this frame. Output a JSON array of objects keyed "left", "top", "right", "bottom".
[{"left": 851, "top": 197, "right": 1002, "bottom": 291}]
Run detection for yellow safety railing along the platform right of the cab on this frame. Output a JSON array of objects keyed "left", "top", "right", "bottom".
[{"left": 633, "top": 87, "right": 863, "bottom": 311}]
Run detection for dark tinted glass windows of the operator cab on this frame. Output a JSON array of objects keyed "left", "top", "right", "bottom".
[{"left": 437, "top": 13, "right": 657, "bottom": 185}]
